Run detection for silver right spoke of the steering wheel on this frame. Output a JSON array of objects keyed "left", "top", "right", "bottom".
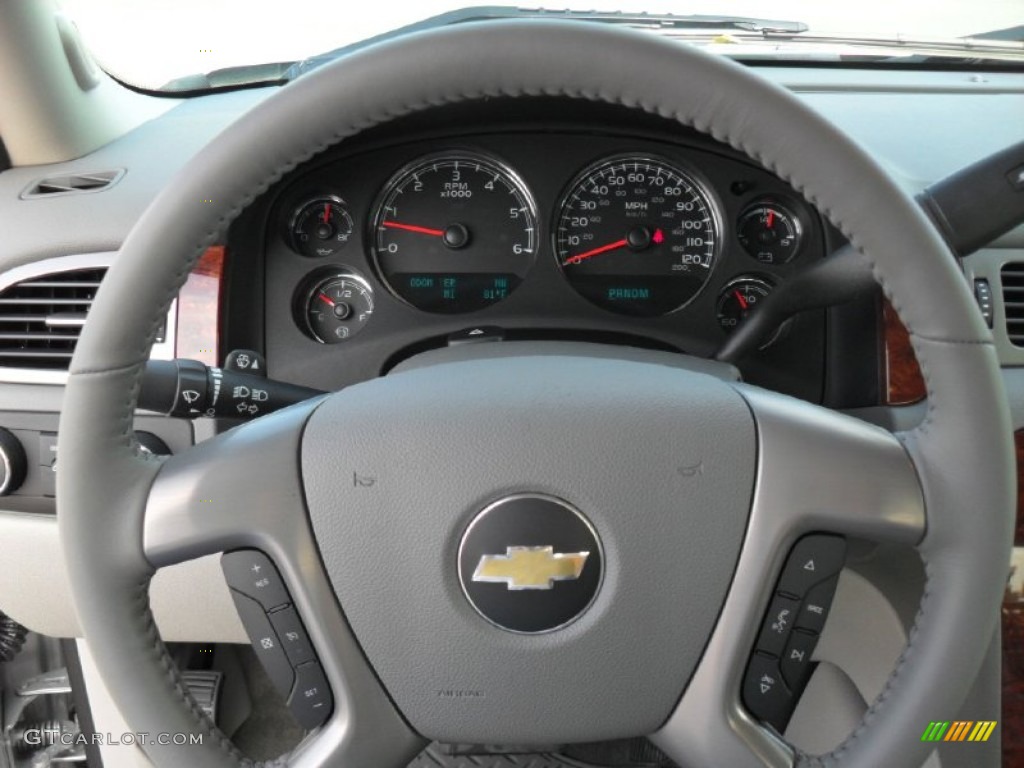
[{"left": 653, "top": 385, "right": 925, "bottom": 768}]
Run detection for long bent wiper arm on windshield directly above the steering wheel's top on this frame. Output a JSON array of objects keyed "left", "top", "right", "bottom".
[{"left": 284, "top": 5, "right": 808, "bottom": 80}]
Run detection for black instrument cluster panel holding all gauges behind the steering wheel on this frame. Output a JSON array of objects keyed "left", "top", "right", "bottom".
[{"left": 234, "top": 99, "right": 842, "bottom": 400}]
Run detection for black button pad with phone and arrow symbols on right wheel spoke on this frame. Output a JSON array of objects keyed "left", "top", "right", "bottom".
[{"left": 741, "top": 534, "right": 846, "bottom": 733}]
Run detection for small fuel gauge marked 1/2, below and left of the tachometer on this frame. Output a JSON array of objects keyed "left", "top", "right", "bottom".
[{"left": 298, "top": 271, "right": 374, "bottom": 344}]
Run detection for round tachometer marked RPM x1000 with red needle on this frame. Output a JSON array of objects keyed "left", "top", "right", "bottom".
[{"left": 372, "top": 153, "right": 538, "bottom": 313}]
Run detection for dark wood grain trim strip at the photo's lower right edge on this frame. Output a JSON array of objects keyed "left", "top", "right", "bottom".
[{"left": 999, "top": 430, "right": 1024, "bottom": 765}]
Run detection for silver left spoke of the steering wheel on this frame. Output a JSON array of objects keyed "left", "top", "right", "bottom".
[{"left": 143, "top": 400, "right": 422, "bottom": 766}]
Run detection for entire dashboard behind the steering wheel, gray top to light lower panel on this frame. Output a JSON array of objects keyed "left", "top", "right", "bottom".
[{"left": 0, "top": 46, "right": 1024, "bottom": 765}]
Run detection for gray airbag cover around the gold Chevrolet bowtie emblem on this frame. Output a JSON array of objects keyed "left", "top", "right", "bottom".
[{"left": 302, "top": 356, "right": 756, "bottom": 743}]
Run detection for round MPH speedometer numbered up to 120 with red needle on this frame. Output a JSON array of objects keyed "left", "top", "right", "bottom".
[{"left": 555, "top": 156, "right": 720, "bottom": 317}]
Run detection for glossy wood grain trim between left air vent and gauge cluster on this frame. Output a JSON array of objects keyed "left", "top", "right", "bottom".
[{"left": 174, "top": 246, "right": 227, "bottom": 366}]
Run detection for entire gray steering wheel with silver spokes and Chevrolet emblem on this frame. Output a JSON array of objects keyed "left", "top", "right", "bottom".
[{"left": 57, "top": 22, "right": 1014, "bottom": 768}]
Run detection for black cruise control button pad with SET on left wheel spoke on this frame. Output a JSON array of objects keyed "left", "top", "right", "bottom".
[{"left": 220, "top": 549, "right": 334, "bottom": 730}]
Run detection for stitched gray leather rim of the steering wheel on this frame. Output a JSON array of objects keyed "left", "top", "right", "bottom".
[{"left": 57, "top": 22, "right": 1014, "bottom": 768}]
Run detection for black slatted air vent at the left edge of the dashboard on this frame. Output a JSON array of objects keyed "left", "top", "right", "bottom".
[{"left": 0, "top": 267, "right": 106, "bottom": 371}]
